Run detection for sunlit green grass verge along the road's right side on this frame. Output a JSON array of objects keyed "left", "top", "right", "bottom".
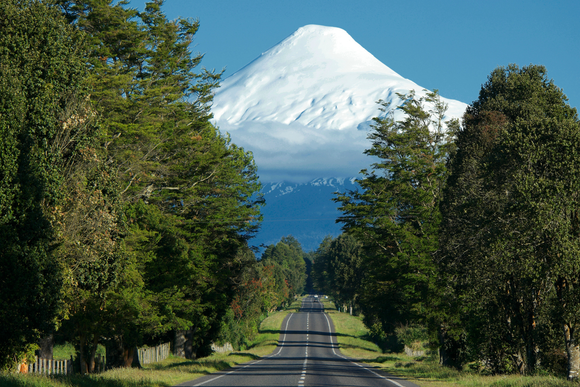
[{"left": 323, "top": 300, "right": 578, "bottom": 387}]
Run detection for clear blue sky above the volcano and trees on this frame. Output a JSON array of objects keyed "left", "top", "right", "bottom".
[{"left": 130, "top": 0, "right": 580, "bottom": 108}]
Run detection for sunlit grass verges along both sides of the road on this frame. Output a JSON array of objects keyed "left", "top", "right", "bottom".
[{"left": 0, "top": 300, "right": 578, "bottom": 387}]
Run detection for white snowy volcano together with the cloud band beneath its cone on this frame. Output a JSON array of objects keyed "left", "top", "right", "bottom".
[{"left": 212, "top": 25, "right": 466, "bottom": 182}]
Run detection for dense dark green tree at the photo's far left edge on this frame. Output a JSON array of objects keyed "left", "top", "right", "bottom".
[{"left": 0, "top": 0, "right": 98, "bottom": 367}]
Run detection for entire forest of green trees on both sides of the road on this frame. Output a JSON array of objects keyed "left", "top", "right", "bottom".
[{"left": 0, "top": 0, "right": 580, "bottom": 379}]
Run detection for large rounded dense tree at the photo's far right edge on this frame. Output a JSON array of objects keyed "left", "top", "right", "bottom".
[{"left": 438, "top": 65, "right": 580, "bottom": 377}]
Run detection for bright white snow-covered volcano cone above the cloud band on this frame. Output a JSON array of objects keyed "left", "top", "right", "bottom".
[{"left": 213, "top": 25, "right": 422, "bottom": 130}]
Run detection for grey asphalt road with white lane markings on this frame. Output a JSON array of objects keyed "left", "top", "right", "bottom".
[{"left": 180, "top": 296, "right": 416, "bottom": 387}]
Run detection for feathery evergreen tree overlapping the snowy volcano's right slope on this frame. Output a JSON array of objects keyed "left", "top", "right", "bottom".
[{"left": 335, "top": 92, "right": 457, "bottom": 333}]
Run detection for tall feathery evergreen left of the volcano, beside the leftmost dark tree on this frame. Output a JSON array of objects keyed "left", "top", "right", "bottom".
[{"left": 53, "top": 0, "right": 261, "bottom": 366}]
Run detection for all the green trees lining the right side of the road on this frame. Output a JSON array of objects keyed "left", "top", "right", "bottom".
[{"left": 313, "top": 65, "right": 580, "bottom": 379}]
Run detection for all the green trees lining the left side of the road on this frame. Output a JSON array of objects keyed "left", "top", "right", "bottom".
[{"left": 0, "top": 0, "right": 284, "bottom": 373}]
